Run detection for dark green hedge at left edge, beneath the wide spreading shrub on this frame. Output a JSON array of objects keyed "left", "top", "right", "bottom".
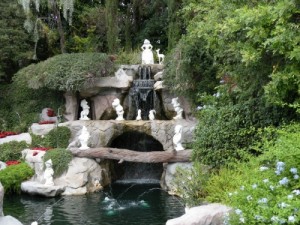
[{"left": 0, "top": 80, "right": 64, "bottom": 133}]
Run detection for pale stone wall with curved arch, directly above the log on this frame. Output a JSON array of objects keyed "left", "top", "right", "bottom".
[{"left": 59, "top": 120, "right": 196, "bottom": 151}]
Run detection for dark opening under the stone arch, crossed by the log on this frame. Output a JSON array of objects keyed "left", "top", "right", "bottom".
[{"left": 110, "top": 131, "right": 164, "bottom": 182}]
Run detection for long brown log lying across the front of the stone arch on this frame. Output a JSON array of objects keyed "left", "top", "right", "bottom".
[{"left": 70, "top": 147, "right": 192, "bottom": 163}]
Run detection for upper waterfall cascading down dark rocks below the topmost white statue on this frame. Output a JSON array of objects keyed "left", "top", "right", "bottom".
[{"left": 129, "top": 66, "right": 156, "bottom": 120}]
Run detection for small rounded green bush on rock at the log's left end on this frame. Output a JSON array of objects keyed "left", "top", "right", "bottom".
[{"left": 43, "top": 148, "right": 73, "bottom": 177}]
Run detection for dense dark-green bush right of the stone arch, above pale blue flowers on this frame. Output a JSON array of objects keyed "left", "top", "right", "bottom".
[{"left": 193, "top": 90, "right": 289, "bottom": 168}]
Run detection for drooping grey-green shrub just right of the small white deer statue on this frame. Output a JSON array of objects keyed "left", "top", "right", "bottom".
[{"left": 164, "top": 37, "right": 219, "bottom": 101}]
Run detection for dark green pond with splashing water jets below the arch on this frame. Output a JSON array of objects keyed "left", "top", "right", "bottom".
[{"left": 4, "top": 181, "right": 184, "bottom": 225}]
